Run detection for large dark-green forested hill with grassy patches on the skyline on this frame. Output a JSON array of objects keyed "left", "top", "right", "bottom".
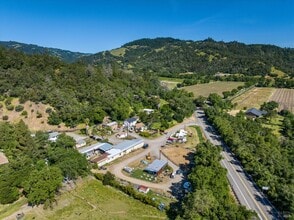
[{"left": 83, "top": 38, "right": 294, "bottom": 77}]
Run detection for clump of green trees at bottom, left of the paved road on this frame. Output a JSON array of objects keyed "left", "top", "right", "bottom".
[{"left": 176, "top": 142, "right": 256, "bottom": 220}]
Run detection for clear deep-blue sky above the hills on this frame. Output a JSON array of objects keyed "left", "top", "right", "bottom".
[{"left": 0, "top": 0, "right": 294, "bottom": 53}]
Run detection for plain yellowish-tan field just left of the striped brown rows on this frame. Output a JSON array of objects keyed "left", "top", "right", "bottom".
[{"left": 232, "top": 87, "right": 275, "bottom": 110}]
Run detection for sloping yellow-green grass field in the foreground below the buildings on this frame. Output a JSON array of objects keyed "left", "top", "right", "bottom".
[{"left": 12, "top": 179, "right": 167, "bottom": 220}]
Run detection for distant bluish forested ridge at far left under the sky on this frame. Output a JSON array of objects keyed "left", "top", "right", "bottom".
[{"left": 0, "top": 41, "right": 90, "bottom": 62}]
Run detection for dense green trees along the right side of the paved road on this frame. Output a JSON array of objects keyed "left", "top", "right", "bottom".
[{"left": 205, "top": 95, "right": 294, "bottom": 216}]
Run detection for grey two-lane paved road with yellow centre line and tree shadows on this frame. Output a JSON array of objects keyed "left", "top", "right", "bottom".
[{"left": 195, "top": 110, "right": 281, "bottom": 219}]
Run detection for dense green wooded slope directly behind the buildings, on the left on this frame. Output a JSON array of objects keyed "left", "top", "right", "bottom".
[{"left": 0, "top": 48, "right": 194, "bottom": 129}]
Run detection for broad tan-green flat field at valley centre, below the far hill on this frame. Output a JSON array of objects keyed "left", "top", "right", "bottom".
[{"left": 183, "top": 81, "right": 244, "bottom": 97}]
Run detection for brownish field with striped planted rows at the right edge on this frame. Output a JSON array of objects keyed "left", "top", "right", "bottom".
[{"left": 269, "top": 89, "right": 294, "bottom": 112}]
